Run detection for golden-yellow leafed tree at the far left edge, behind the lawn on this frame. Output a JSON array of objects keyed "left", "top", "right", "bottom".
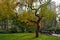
[{"left": 0, "top": 0, "right": 16, "bottom": 30}]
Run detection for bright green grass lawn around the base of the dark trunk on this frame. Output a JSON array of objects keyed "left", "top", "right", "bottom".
[{"left": 0, "top": 33, "right": 60, "bottom": 40}]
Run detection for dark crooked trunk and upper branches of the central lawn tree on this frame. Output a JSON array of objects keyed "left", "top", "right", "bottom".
[{"left": 14, "top": 0, "right": 56, "bottom": 37}]
